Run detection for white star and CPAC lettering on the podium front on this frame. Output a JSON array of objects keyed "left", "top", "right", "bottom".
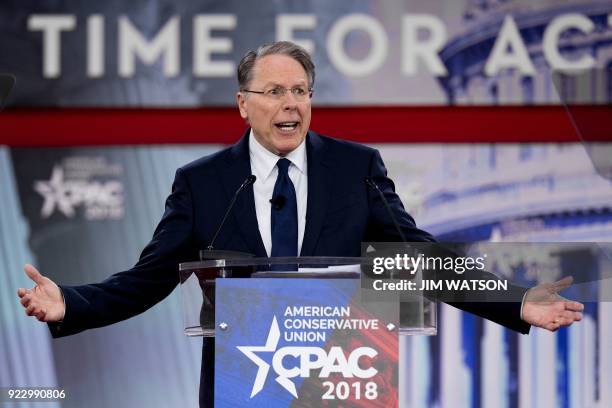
[{"left": 238, "top": 316, "right": 378, "bottom": 398}]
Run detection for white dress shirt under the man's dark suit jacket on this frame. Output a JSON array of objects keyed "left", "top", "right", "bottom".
[{"left": 249, "top": 129, "right": 308, "bottom": 256}]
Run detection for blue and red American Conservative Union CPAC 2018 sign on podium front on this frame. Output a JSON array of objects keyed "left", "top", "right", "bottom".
[{"left": 215, "top": 279, "right": 398, "bottom": 408}]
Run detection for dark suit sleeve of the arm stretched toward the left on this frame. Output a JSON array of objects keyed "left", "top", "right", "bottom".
[{"left": 49, "top": 169, "right": 197, "bottom": 337}]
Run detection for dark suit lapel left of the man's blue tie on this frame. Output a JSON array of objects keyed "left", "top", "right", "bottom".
[{"left": 218, "top": 129, "right": 268, "bottom": 257}]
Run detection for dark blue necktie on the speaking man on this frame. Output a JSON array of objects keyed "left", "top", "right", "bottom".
[{"left": 270, "top": 159, "right": 297, "bottom": 262}]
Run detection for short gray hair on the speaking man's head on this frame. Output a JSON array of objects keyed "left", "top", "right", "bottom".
[{"left": 237, "top": 41, "right": 315, "bottom": 90}]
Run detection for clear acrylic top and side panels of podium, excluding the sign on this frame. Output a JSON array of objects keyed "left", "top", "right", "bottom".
[{"left": 179, "top": 257, "right": 437, "bottom": 337}]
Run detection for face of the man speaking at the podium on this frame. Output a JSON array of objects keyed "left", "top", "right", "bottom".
[{"left": 236, "top": 55, "right": 311, "bottom": 156}]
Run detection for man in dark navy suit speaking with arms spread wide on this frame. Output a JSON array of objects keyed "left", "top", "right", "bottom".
[{"left": 18, "top": 42, "right": 582, "bottom": 406}]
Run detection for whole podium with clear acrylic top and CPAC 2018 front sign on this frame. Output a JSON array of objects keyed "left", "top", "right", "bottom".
[{"left": 179, "top": 257, "right": 437, "bottom": 408}]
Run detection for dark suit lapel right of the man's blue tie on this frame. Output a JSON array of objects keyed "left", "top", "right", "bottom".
[{"left": 300, "top": 132, "right": 333, "bottom": 256}]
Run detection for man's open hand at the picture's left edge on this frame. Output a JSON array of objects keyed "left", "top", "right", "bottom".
[{"left": 17, "top": 264, "right": 65, "bottom": 322}]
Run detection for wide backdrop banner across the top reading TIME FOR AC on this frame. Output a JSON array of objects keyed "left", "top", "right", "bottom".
[{"left": 0, "top": 0, "right": 612, "bottom": 107}]
